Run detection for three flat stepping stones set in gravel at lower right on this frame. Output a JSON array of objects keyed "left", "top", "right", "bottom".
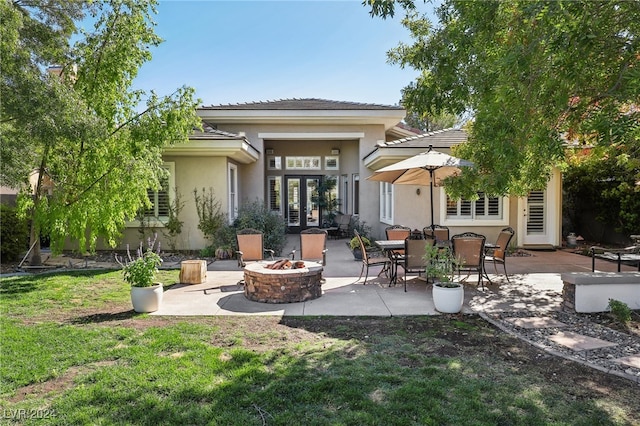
[{"left": 504, "top": 317, "right": 640, "bottom": 382}]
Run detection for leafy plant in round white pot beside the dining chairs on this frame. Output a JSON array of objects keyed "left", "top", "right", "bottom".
[{"left": 424, "top": 245, "right": 464, "bottom": 314}]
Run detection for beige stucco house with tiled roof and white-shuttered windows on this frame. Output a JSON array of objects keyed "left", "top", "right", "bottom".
[{"left": 123, "top": 99, "right": 561, "bottom": 250}]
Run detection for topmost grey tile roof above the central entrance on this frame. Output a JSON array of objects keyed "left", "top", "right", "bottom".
[{"left": 200, "top": 98, "right": 404, "bottom": 110}]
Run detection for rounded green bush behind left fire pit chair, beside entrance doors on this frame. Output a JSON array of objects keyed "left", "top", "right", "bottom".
[{"left": 233, "top": 200, "right": 287, "bottom": 256}]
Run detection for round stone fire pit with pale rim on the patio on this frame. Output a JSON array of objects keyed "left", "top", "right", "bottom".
[{"left": 244, "top": 261, "right": 322, "bottom": 303}]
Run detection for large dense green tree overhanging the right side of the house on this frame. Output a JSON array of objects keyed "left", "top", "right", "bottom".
[{"left": 364, "top": 0, "right": 640, "bottom": 201}]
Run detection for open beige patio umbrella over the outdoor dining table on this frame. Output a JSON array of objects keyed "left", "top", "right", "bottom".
[{"left": 367, "top": 145, "right": 473, "bottom": 227}]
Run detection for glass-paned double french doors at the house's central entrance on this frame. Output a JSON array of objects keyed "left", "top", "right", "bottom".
[{"left": 284, "top": 176, "right": 322, "bottom": 233}]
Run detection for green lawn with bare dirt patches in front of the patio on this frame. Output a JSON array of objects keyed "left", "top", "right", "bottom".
[{"left": 0, "top": 271, "right": 640, "bottom": 425}]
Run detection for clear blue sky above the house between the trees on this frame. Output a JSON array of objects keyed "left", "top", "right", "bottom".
[{"left": 127, "top": 0, "right": 428, "bottom": 105}]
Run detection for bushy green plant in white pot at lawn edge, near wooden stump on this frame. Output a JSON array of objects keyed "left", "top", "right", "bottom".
[{"left": 116, "top": 239, "right": 163, "bottom": 312}]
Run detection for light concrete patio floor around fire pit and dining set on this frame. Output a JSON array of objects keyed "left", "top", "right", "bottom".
[{"left": 152, "top": 235, "right": 635, "bottom": 316}]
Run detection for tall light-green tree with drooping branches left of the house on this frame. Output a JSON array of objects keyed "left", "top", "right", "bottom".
[{"left": 0, "top": 0, "right": 199, "bottom": 264}]
